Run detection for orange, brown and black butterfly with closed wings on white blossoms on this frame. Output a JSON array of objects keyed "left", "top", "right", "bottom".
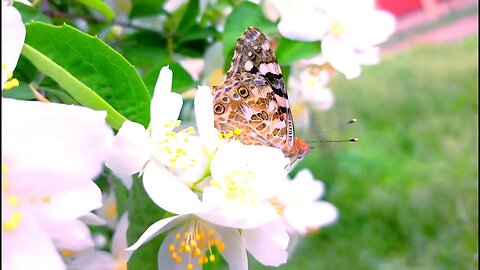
[{"left": 212, "top": 27, "right": 311, "bottom": 164}]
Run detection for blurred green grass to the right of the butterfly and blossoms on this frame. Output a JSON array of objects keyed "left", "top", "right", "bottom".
[{"left": 246, "top": 36, "right": 478, "bottom": 270}]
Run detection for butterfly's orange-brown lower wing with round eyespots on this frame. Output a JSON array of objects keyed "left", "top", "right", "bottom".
[{"left": 213, "top": 72, "right": 291, "bottom": 153}]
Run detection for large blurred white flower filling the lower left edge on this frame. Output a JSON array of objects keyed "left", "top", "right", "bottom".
[{"left": 2, "top": 99, "right": 113, "bottom": 269}]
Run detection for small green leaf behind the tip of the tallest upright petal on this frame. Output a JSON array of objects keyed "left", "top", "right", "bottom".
[{"left": 143, "top": 61, "right": 197, "bottom": 95}]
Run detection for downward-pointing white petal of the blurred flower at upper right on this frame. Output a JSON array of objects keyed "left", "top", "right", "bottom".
[{"left": 322, "top": 35, "right": 362, "bottom": 80}]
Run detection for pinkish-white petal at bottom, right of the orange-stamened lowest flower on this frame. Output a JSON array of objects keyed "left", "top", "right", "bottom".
[{"left": 242, "top": 222, "right": 289, "bottom": 266}]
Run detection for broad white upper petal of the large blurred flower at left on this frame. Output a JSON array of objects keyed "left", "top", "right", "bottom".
[{"left": 2, "top": 98, "right": 113, "bottom": 190}]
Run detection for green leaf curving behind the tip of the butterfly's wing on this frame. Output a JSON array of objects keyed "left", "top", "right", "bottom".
[{"left": 223, "top": 1, "right": 277, "bottom": 66}]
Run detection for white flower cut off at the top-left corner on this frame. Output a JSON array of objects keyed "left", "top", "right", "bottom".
[{"left": 2, "top": 0, "right": 25, "bottom": 89}]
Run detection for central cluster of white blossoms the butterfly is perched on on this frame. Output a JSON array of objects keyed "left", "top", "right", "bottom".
[{"left": 107, "top": 67, "right": 337, "bottom": 269}]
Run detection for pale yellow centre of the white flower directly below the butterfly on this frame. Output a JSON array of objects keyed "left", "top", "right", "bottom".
[{"left": 210, "top": 170, "right": 260, "bottom": 204}]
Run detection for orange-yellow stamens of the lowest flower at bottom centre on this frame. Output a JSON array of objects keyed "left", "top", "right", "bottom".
[{"left": 168, "top": 220, "right": 225, "bottom": 270}]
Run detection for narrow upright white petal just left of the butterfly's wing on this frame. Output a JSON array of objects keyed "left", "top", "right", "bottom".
[{"left": 194, "top": 86, "right": 218, "bottom": 153}]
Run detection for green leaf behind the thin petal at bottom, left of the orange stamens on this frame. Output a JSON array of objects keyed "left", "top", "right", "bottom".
[{"left": 127, "top": 177, "right": 165, "bottom": 270}]
